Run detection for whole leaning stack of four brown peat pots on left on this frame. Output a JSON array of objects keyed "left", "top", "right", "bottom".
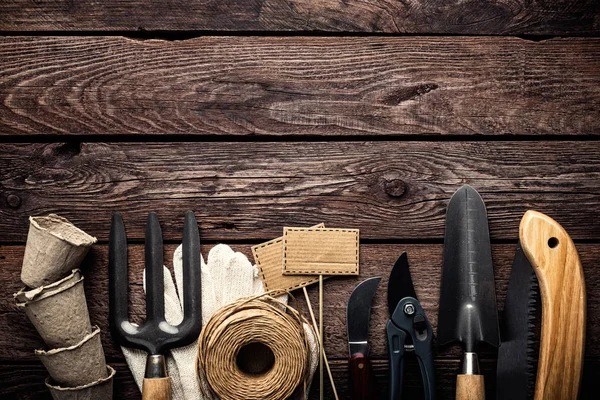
[{"left": 14, "top": 214, "right": 115, "bottom": 400}]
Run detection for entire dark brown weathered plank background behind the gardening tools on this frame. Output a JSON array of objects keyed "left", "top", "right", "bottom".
[{"left": 0, "top": 0, "right": 600, "bottom": 399}]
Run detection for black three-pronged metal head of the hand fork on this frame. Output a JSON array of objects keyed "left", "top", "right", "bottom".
[{"left": 108, "top": 211, "right": 202, "bottom": 355}]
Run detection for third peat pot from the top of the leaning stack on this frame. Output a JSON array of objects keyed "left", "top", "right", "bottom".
[{"left": 35, "top": 327, "right": 107, "bottom": 387}]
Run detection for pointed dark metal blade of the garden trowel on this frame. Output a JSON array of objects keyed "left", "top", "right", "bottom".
[{"left": 437, "top": 185, "right": 500, "bottom": 353}]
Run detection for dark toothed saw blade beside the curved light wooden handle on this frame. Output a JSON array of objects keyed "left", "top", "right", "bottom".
[{"left": 496, "top": 243, "right": 539, "bottom": 400}]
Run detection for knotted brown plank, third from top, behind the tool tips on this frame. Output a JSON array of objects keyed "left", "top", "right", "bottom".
[{"left": 0, "top": 141, "right": 600, "bottom": 242}]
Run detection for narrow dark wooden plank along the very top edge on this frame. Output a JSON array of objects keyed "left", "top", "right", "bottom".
[{"left": 0, "top": 0, "right": 599, "bottom": 35}]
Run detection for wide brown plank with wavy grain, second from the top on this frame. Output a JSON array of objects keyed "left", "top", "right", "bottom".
[{"left": 0, "top": 37, "right": 600, "bottom": 136}]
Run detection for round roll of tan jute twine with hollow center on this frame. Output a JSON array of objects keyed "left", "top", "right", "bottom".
[{"left": 197, "top": 294, "right": 312, "bottom": 400}]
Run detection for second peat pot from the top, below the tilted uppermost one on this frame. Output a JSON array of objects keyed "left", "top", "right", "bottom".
[{"left": 14, "top": 270, "right": 92, "bottom": 349}]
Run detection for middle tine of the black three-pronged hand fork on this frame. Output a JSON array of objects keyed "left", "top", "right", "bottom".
[{"left": 145, "top": 212, "right": 165, "bottom": 325}]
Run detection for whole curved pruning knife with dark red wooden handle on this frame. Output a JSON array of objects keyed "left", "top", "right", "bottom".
[{"left": 346, "top": 277, "right": 381, "bottom": 400}]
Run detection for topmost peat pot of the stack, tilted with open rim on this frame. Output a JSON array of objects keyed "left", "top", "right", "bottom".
[{"left": 21, "top": 214, "right": 96, "bottom": 287}]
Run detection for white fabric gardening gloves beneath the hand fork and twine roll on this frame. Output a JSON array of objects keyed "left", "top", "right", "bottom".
[{"left": 121, "top": 244, "right": 318, "bottom": 400}]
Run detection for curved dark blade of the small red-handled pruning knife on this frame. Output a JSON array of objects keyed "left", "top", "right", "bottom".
[{"left": 346, "top": 277, "right": 381, "bottom": 356}]
